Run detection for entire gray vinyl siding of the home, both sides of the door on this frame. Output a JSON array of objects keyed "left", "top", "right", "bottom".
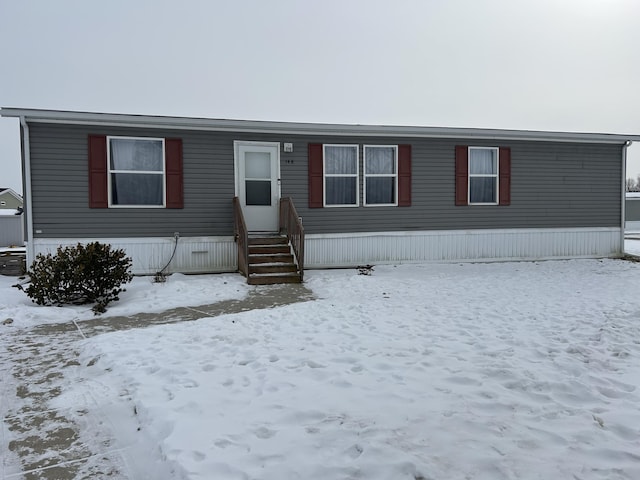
[{"left": 30, "top": 124, "right": 622, "bottom": 238}]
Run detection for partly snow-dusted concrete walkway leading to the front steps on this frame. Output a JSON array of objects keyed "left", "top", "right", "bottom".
[{"left": 0, "top": 284, "right": 314, "bottom": 480}]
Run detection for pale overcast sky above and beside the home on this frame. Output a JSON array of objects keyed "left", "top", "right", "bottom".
[{"left": 0, "top": 0, "right": 640, "bottom": 192}]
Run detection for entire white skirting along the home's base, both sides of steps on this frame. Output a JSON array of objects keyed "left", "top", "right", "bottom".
[{"left": 27, "top": 227, "right": 622, "bottom": 275}]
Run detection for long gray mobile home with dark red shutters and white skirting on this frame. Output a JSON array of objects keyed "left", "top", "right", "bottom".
[{"left": 0, "top": 108, "right": 640, "bottom": 273}]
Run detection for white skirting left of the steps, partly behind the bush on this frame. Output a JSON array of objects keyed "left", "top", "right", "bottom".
[{"left": 27, "top": 237, "right": 238, "bottom": 275}]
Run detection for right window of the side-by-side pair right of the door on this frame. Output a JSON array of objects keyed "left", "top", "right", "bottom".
[{"left": 364, "top": 145, "right": 398, "bottom": 206}]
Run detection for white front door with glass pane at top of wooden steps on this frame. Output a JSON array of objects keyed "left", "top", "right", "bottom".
[{"left": 234, "top": 141, "right": 280, "bottom": 232}]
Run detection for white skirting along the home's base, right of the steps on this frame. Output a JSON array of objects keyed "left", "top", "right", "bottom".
[{"left": 305, "top": 228, "right": 622, "bottom": 268}]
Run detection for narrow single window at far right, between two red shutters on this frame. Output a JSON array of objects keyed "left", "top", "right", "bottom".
[{"left": 468, "top": 147, "right": 499, "bottom": 205}]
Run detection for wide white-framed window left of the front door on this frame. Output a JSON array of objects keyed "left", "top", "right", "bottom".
[{"left": 107, "top": 137, "right": 166, "bottom": 208}]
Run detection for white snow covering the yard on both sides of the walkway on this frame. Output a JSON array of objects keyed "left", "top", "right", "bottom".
[{"left": 5, "top": 260, "right": 640, "bottom": 480}]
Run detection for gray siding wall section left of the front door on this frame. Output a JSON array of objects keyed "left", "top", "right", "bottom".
[{"left": 29, "top": 124, "right": 234, "bottom": 239}]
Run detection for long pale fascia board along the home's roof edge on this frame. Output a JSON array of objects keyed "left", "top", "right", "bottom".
[{"left": 0, "top": 107, "right": 640, "bottom": 144}]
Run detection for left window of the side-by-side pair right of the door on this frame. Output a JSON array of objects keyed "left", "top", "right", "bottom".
[{"left": 323, "top": 144, "right": 359, "bottom": 207}]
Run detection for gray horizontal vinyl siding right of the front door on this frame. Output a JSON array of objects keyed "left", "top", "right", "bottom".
[{"left": 296, "top": 138, "right": 622, "bottom": 233}]
